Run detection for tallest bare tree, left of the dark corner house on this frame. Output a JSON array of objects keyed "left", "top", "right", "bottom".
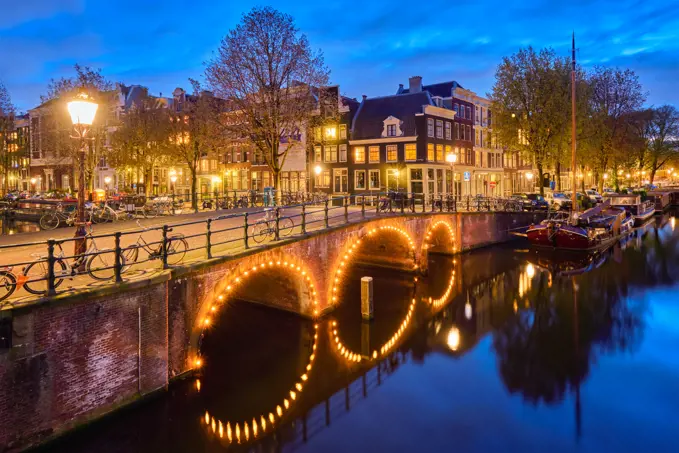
[{"left": 205, "top": 7, "right": 329, "bottom": 200}]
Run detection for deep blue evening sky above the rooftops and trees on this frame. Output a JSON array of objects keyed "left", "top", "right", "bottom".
[{"left": 0, "top": 0, "right": 679, "bottom": 110}]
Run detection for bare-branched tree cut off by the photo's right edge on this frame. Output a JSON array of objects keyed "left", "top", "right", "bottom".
[{"left": 647, "top": 105, "right": 679, "bottom": 184}]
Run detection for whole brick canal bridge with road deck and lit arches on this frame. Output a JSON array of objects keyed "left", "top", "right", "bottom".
[{"left": 0, "top": 197, "right": 539, "bottom": 452}]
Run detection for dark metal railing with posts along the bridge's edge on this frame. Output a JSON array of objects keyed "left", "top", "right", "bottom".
[{"left": 0, "top": 192, "right": 521, "bottom": 307}]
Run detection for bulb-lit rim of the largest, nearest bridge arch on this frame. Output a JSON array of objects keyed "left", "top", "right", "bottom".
[{"left": 188, "top": 254, "right": 319, "bottom": 369}]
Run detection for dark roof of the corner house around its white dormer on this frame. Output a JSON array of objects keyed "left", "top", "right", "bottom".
[{"left": 351, "top": 92, "right": 433, "bottom": 140}]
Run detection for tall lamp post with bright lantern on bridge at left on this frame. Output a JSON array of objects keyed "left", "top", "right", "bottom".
[{"left": 68, "top": 92, "right": 99, "bottom": 263}]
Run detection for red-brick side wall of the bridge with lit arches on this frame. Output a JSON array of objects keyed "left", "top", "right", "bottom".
[{"left": 0, "top": 213, "right": 536, "bottom": 451}]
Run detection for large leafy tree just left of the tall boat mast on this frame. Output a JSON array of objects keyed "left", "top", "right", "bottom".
[{"left": 491, "top": 47, "right": 570, "bottom": 194}]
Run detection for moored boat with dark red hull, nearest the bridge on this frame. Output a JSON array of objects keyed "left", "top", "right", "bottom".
[{"left": 526, "top": 200, "right": 634, "bottom": 251}]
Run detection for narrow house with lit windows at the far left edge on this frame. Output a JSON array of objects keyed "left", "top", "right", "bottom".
[{"left": 0, "top": 115, "right": 31, "bottom": 190}]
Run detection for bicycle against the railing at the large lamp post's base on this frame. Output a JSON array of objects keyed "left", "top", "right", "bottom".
[{"left": 23, "top": 222, "right": 125, "bottom": 295}]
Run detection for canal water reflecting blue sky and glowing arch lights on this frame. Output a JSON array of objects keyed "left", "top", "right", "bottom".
[{"left": 33, "top": 216, "right": 679, "bottom": 453}]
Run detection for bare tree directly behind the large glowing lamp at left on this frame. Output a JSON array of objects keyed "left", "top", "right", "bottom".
[{"left": 40, "top": 64, "right": 115, "bottom": 190}]
